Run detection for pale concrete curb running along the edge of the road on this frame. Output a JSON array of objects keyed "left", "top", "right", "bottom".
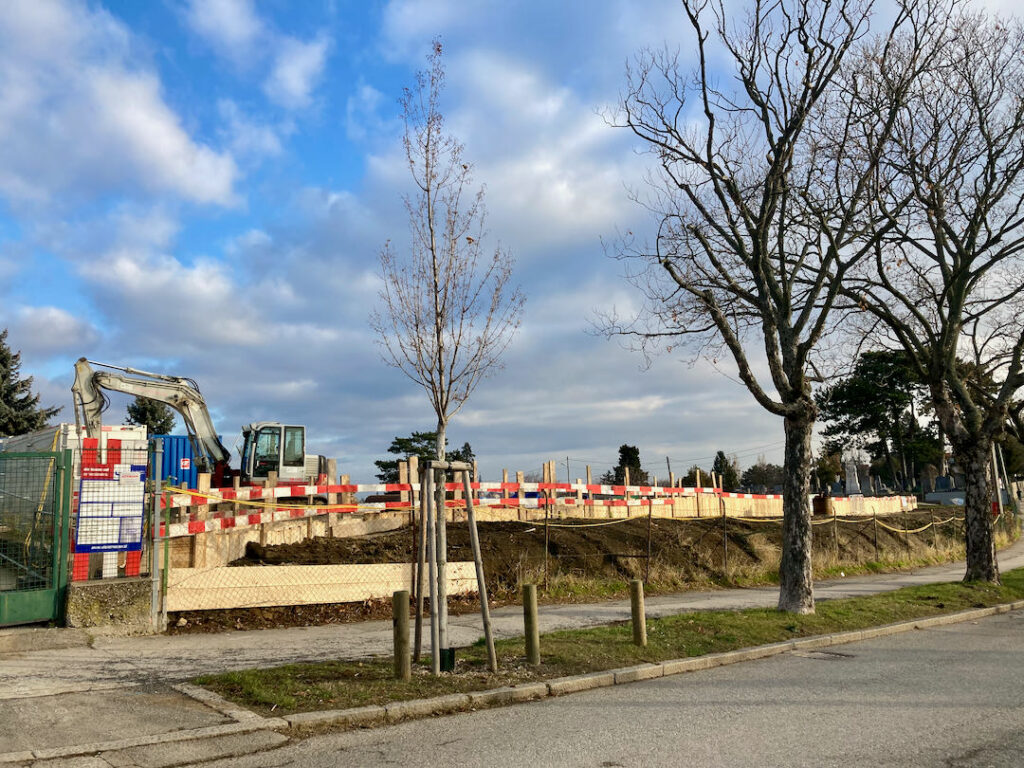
[{"left": 0, "top": 600, "right": 1024, "bottom": 764}]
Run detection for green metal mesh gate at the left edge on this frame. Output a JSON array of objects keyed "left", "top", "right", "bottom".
[{"left": 0, "top": 451, "right": 72, "bottom": 627}]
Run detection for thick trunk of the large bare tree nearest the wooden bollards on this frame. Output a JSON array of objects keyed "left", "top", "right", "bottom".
[{"left": 778, "top": 417, "right": 814, "bottom": 613}]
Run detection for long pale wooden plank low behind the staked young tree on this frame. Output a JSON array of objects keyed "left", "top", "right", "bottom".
[{"left": 167, "top": 562, "right": 476, "bottom": 611}]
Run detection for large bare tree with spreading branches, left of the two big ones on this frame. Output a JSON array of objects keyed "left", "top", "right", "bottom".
[{"left": 606, "top": 0, "right": 927, "bottom": 612}]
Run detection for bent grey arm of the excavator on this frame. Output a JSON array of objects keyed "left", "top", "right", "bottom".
[{"left": 71, "top": 357, "right": 230, "bottom": 476}]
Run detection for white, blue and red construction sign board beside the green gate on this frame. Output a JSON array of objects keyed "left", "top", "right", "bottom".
[{"left": 75, "top": 440, "right": 145, "bottom": 552}]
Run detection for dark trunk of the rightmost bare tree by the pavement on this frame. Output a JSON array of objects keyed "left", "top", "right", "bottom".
[{"left": 957, "top": 439, "right": 999, "bottom": 584}]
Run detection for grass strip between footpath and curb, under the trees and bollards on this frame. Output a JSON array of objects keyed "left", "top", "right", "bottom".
[{"left": 195, "top": 569, "right": 1024, "bottom": 715}]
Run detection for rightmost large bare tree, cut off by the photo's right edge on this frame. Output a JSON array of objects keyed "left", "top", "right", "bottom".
[{"left": 845, "top": 8, "right": 1024, "bottom": 582}]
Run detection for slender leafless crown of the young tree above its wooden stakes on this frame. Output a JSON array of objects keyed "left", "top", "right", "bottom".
[{"left": 370, "top": 40, "right": 523, "bottom": 460}]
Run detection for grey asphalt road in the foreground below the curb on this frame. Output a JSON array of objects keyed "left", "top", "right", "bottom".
[{"left": 188, "top": 612, "right": 1024, "bottom": 768}]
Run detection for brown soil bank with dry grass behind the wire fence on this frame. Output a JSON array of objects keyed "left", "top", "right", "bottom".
[{"left": 168, "top": 509, "right": 963, "bottom": 634}]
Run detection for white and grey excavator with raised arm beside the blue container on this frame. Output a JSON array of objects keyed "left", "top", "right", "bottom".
[{"left": 71, "top": 357, "right": 327, "bottom": 487}]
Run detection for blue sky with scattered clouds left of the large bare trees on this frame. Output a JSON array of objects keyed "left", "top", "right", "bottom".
[{"left": 0, "top": 0, "right": 1015, "bottom": 482}]
